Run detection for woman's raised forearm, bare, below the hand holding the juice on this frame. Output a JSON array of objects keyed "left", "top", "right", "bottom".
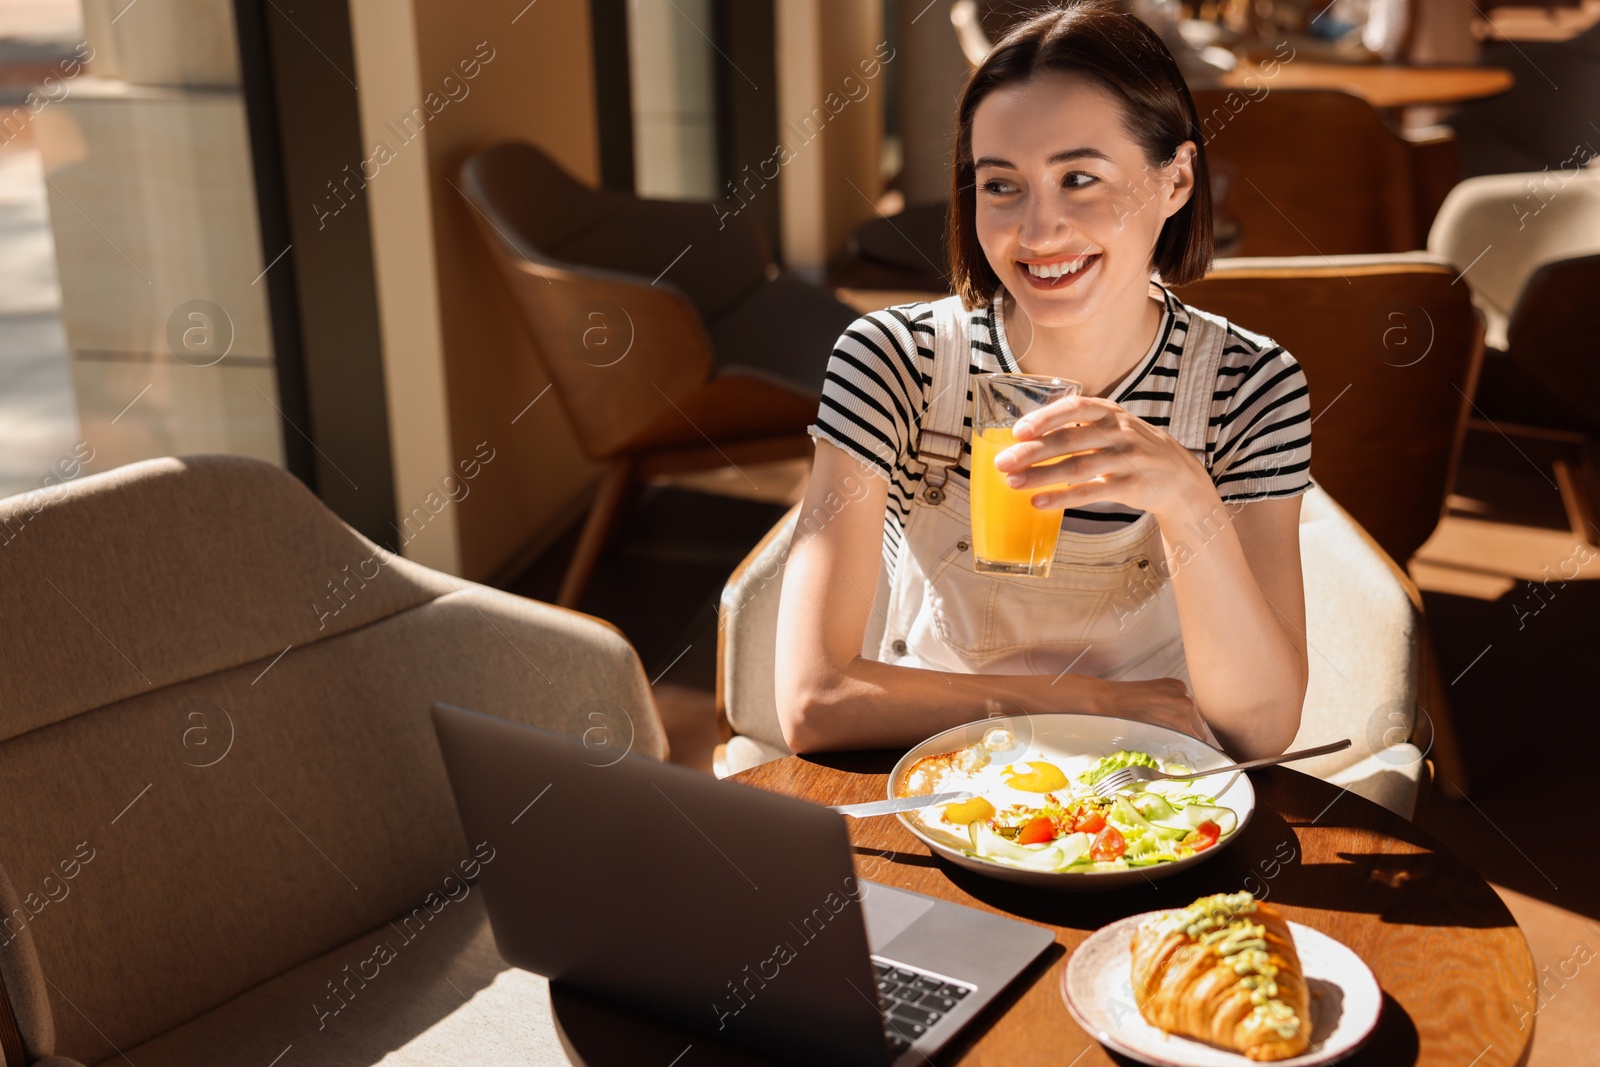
[{"left": 1158, "top": 486, "right": 1307, "bottom": 758}]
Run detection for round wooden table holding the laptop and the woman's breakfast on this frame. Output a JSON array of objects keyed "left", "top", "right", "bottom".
[{"left": 736, "top": 752, "right": 1536, "bottom": 1067}]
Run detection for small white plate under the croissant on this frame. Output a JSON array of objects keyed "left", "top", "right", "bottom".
[{"left": 1061, "top": 915, "right": 1384, "bottom": 1067}]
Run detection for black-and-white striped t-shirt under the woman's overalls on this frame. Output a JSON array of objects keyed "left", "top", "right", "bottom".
[{"left": 810, "top": 288, "right": 1310, "bottom": 577}]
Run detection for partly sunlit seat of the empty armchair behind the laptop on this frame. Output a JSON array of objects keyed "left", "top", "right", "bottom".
[{"left": 101, "top": 889, "right": 570, "bottom": 1067}]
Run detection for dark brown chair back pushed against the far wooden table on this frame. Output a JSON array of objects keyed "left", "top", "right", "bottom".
[{"left": 1194, "top": 83, "right": 1458, "bottom": 256}]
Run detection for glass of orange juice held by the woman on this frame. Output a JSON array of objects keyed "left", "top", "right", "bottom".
[{"left": 971, "top": 374, "right": 1083, "bottom": 577}]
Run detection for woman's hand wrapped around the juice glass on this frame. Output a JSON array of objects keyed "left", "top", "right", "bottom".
[{"left": 995, "top": 397, "right": 1216, "bottom": 522}]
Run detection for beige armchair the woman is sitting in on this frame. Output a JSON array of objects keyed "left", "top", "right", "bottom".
[{"left": 717, "top": 486, "right": 1427, "bottom": 817}]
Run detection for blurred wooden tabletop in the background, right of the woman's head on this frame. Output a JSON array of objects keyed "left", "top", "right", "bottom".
[{"left": 1219, "top": 59, "right": 1514, "bottom": 107}]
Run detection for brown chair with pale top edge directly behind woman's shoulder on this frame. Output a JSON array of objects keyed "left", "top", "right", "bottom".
[{"left": 1178, "top": 253, "right": 1483, "bottom": 793}]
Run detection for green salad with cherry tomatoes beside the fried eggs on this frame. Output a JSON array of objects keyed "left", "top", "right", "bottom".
[{"left": 946, "top": 750, "right": 1238, "bottom": 873}]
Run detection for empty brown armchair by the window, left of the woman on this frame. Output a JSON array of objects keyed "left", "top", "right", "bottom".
[{"left": 461, "top": 142, "right": 856, "bottom": 606}]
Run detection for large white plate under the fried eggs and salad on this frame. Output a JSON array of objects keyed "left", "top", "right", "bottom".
[{"left": 888, "top": 715, "right": 1256, "bottom": 889}]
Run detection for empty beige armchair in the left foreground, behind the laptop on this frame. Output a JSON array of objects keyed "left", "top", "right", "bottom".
[{"left": 0, "top": 456, "right": 667, "bottom": 1067}]
